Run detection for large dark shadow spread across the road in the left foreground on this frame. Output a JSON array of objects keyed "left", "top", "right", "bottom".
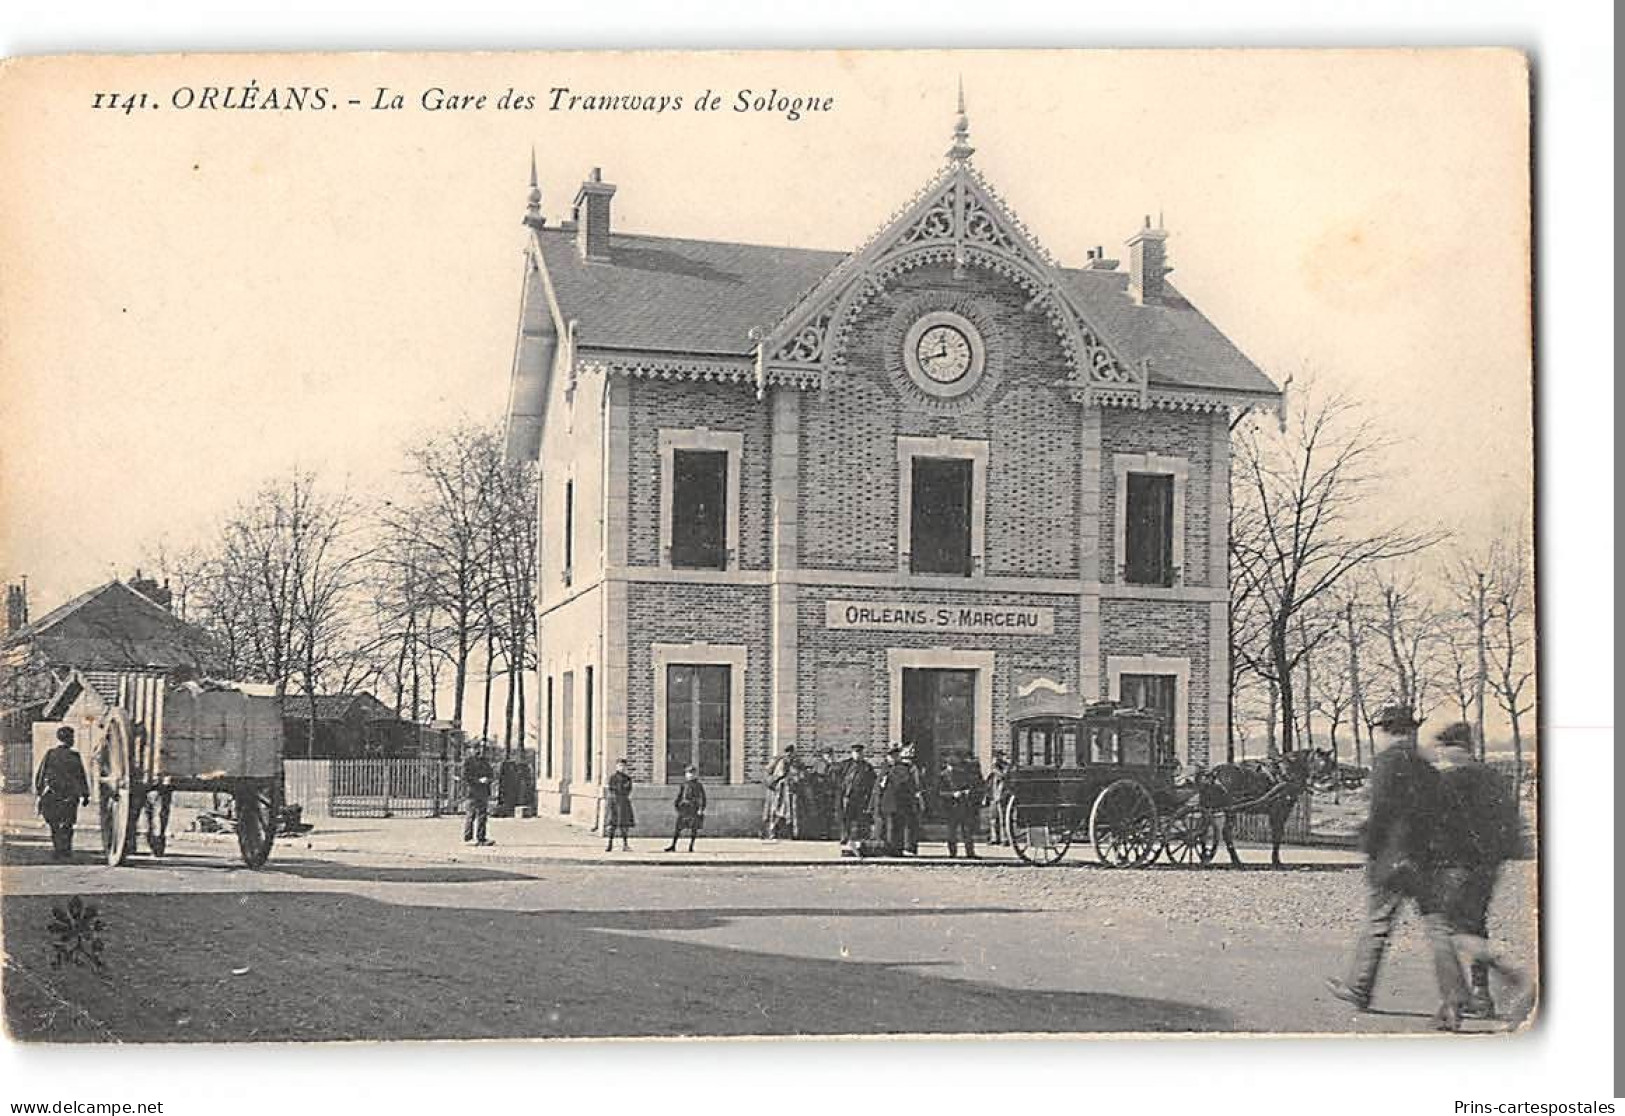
[{"left": 3, "top": 892, "right": 1233, "bottom": 1041}]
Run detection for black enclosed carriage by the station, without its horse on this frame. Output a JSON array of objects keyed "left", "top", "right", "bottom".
[{"left": 1004, "top": 702, "right": 1217, "bottom": 867}]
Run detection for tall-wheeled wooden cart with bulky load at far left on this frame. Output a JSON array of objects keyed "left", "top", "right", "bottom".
[{"left": 89, "top": 674, "right": 283, "bottom": 867}]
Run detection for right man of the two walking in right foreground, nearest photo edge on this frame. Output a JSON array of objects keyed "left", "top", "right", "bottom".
[{"left": 1433, "top": 721, "right": 1529, "bottom": 1019}]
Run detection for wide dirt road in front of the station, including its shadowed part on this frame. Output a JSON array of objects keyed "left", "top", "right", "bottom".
[{"left": 3, "top": 837, "right": 1534, "bottom": 1041}]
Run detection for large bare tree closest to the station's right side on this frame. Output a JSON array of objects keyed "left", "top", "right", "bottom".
[{"left": 1232, "top": 383, "right": 1441, "bottom": 752}]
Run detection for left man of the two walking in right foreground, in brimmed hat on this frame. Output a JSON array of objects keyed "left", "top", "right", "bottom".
[{"left": 1326, "top": 703, "right": 1464, "bottom": 1025}]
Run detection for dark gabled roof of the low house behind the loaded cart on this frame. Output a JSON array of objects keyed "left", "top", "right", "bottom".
[{"left": 3, "top": 580, "right": 218, "bottom": 671}]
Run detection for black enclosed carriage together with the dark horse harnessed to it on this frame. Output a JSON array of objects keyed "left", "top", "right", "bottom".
[{"left": 1004, "top": 702, "right": 1320, "bottom": 867}]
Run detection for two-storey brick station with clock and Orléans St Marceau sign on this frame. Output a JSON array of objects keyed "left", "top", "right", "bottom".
[{"left": 509, "top": 112, "right": 1281, "bottom": 832}]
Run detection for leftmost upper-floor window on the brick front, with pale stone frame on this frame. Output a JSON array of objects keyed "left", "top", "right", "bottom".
[{"left": 660, "top": 427, "right": 744, "bottom": 570}]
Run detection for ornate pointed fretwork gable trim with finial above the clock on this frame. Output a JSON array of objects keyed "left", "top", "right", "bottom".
[{"left": 752, "top": 115, "right": 1147, "bottom": 404}]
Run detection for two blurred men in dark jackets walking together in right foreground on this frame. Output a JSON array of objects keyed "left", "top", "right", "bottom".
[{"left": 1326, "top": 705, "right": 1532, "bottom": 1030}]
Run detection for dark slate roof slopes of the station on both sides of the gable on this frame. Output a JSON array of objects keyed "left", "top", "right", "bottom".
[{"left": 536, "top": 229, "right": 1279, "bottom": 395}]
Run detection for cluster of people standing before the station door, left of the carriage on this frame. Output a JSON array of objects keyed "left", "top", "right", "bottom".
[{"left": 762, "top": 744, "right": 1006, "bottom": 859}]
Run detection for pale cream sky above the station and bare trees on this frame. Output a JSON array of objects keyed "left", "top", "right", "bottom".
[{"left": 0, "top": 50, "right": 1532, "bottom": 616}]
